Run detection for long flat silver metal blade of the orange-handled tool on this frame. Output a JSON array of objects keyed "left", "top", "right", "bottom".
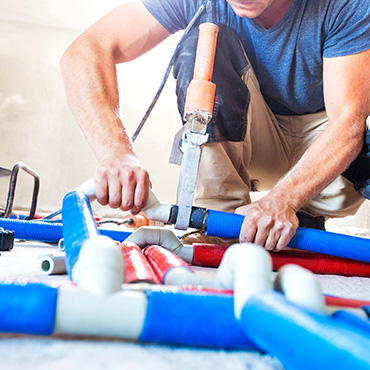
[{"left": 175, "top": 131, "right": 208, "bottom": 230}]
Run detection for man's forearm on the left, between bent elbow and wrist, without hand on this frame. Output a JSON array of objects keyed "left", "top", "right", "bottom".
[{"left": 61, "top": 43, "right": 133, "bottom": 161}]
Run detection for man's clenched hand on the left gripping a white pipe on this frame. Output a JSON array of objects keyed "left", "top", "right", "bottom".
[{"left": 94, "top": 153, "right": 150, "bottom": 215}]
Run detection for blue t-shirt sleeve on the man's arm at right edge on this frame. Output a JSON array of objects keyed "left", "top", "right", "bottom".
[{"left": 323, "top": 0, "right": 370, "bottom": 58}]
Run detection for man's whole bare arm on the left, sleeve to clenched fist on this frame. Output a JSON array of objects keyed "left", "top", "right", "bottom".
[{"left": 61, "top": 0, "right": 170, "bottom": 214}]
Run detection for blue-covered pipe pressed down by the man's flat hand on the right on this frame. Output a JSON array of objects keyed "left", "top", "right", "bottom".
[{"left": 206, "top": 210, "right": 370, "bottom": 262}]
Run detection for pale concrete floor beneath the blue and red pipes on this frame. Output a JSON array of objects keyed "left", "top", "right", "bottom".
[{"left": 0, "top": 237, "right": 370, "bottom": 370}]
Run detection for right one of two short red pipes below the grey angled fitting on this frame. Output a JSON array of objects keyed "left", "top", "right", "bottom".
[{"left": 144, "top": 245, "right": 190, "bottom": 283}]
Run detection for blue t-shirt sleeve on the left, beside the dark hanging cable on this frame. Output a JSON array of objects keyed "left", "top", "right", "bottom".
[{"left": 141, "top": 0, "right": 202, "bottom": 33}]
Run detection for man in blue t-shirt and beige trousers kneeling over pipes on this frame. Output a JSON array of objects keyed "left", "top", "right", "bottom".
[{"left": 61, "top": 0, "right": 370, "bottom": 250}]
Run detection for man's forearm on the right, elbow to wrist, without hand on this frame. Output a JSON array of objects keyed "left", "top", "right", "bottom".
[{"left": 269, "top": 114, "right": 365, "bottom": 211}]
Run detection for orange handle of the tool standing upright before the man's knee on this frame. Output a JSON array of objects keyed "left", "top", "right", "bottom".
[{"left": 185, "top": 23, "right": 219, "bottom": 116}]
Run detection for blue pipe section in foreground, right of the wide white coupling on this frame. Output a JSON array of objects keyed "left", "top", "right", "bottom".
[{"left": 139, "top": 290, "right": 256, "bottom": 350}]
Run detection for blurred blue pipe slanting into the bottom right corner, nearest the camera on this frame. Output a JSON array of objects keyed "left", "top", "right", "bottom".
[{"left": 241, "top": 291, "right": 370, "bottom": 370}]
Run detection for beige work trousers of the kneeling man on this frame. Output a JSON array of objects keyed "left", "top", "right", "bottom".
[{"left": 194, "top": 60, "right": 364, "bottom": 218}]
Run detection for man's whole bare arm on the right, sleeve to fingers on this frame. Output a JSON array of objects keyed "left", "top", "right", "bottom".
[{"left": 237, "top": 50, "right": 370, "bottom": 250}]
